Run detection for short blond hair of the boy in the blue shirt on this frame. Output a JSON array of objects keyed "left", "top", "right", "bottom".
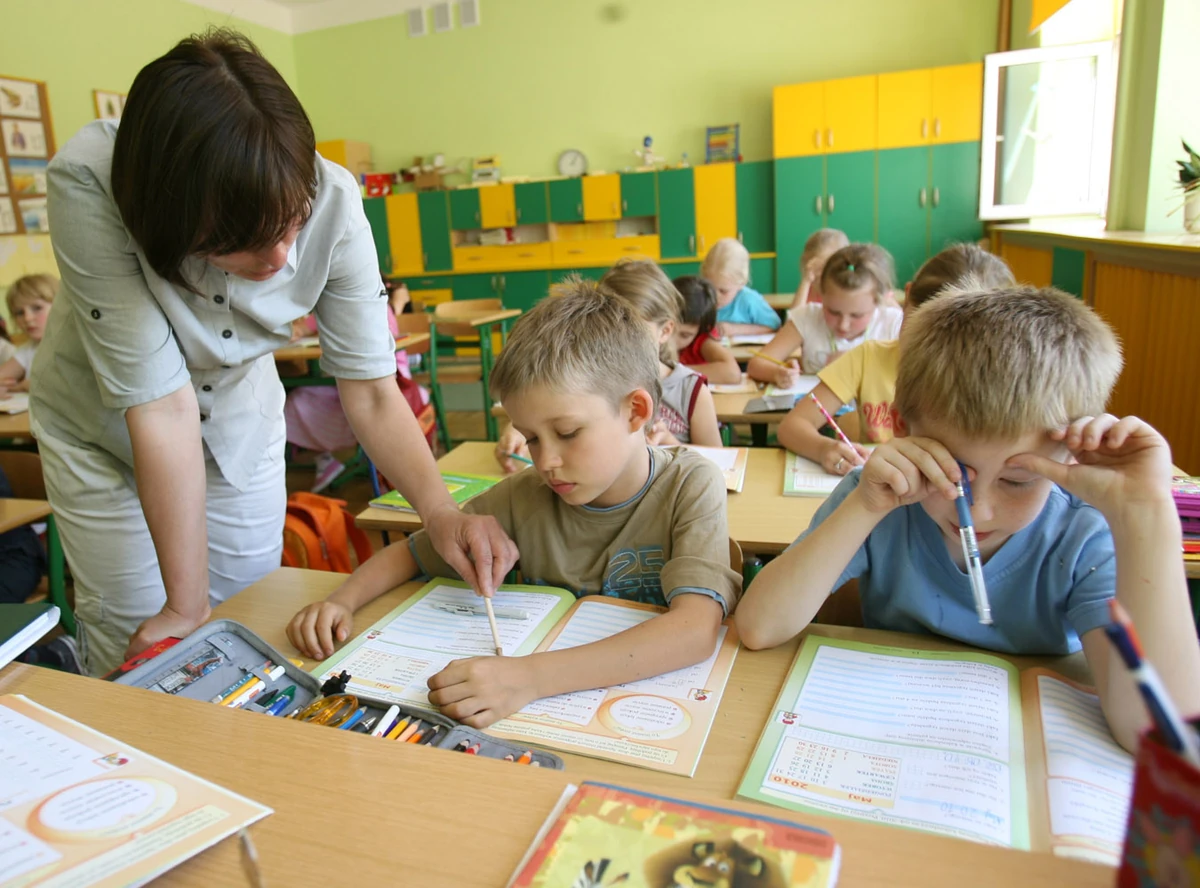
[{"left": 895, "top": 287, "right": 1121, "bottom": 439}]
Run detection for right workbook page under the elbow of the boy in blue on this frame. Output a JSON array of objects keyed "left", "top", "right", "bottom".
[{"left": 1022, "top": 668, "right": 1134, "bottom": 866}]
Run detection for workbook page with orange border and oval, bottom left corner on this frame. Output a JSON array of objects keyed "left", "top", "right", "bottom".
[{"left": 0, "top": 695, "right": 271, "bottom": 888}]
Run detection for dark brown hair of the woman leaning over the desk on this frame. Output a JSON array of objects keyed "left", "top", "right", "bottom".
[{"left": 113, "top": 29, "right": 317, "bottom": 289}]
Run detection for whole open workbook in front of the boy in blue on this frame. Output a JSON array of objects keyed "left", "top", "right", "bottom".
[{"left": 738, "top": 635, "right": 1133, "bottom": 865}]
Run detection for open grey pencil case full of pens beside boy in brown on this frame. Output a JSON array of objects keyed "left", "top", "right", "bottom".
[{"left": 107, "top": 620, "right": 563, "bottom": 770}]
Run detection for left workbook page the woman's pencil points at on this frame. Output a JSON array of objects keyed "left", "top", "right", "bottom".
[{"left": 313, "top": 580, "right": 575, "bottom": 709}]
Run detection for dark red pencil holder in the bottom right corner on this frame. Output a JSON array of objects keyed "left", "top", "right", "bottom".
[{"left": 1116, "top": 721, "right": 1200, "bottom": 888}]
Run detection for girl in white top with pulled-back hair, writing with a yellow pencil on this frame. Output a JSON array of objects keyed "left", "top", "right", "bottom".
[{"left": 746, "top": 244, "right": 904, "bottom": 388}]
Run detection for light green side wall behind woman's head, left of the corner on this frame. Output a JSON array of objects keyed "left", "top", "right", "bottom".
[{"left": 0, "top": 0, "right": 296, "bottom": 152}]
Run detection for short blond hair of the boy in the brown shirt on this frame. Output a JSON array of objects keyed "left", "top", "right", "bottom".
[{"left": 491, "top": 276, "right": 662, "bottom": 409}]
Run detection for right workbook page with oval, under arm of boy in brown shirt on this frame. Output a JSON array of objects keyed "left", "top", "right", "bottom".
[{"left": 488, "top": 595, "right": 738, "bottom": 776}]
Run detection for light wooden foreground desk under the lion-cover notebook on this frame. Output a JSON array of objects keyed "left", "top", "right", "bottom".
[{"left": 0, "top": 662, "right": 1112, "bottom": 888}]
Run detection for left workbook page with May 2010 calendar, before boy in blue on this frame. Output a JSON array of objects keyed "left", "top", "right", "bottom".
[{"left": 738, "top": 635, "right": 1030, "bottom": 850}]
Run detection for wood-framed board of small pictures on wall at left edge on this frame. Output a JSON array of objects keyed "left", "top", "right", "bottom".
[{"left": 0, "top": 76, "right": 55, "bottom": 235}]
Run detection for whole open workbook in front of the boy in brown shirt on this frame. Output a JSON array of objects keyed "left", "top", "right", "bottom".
[{"left": 314, "top": 580, "right": 738, "bottom": 776}]
